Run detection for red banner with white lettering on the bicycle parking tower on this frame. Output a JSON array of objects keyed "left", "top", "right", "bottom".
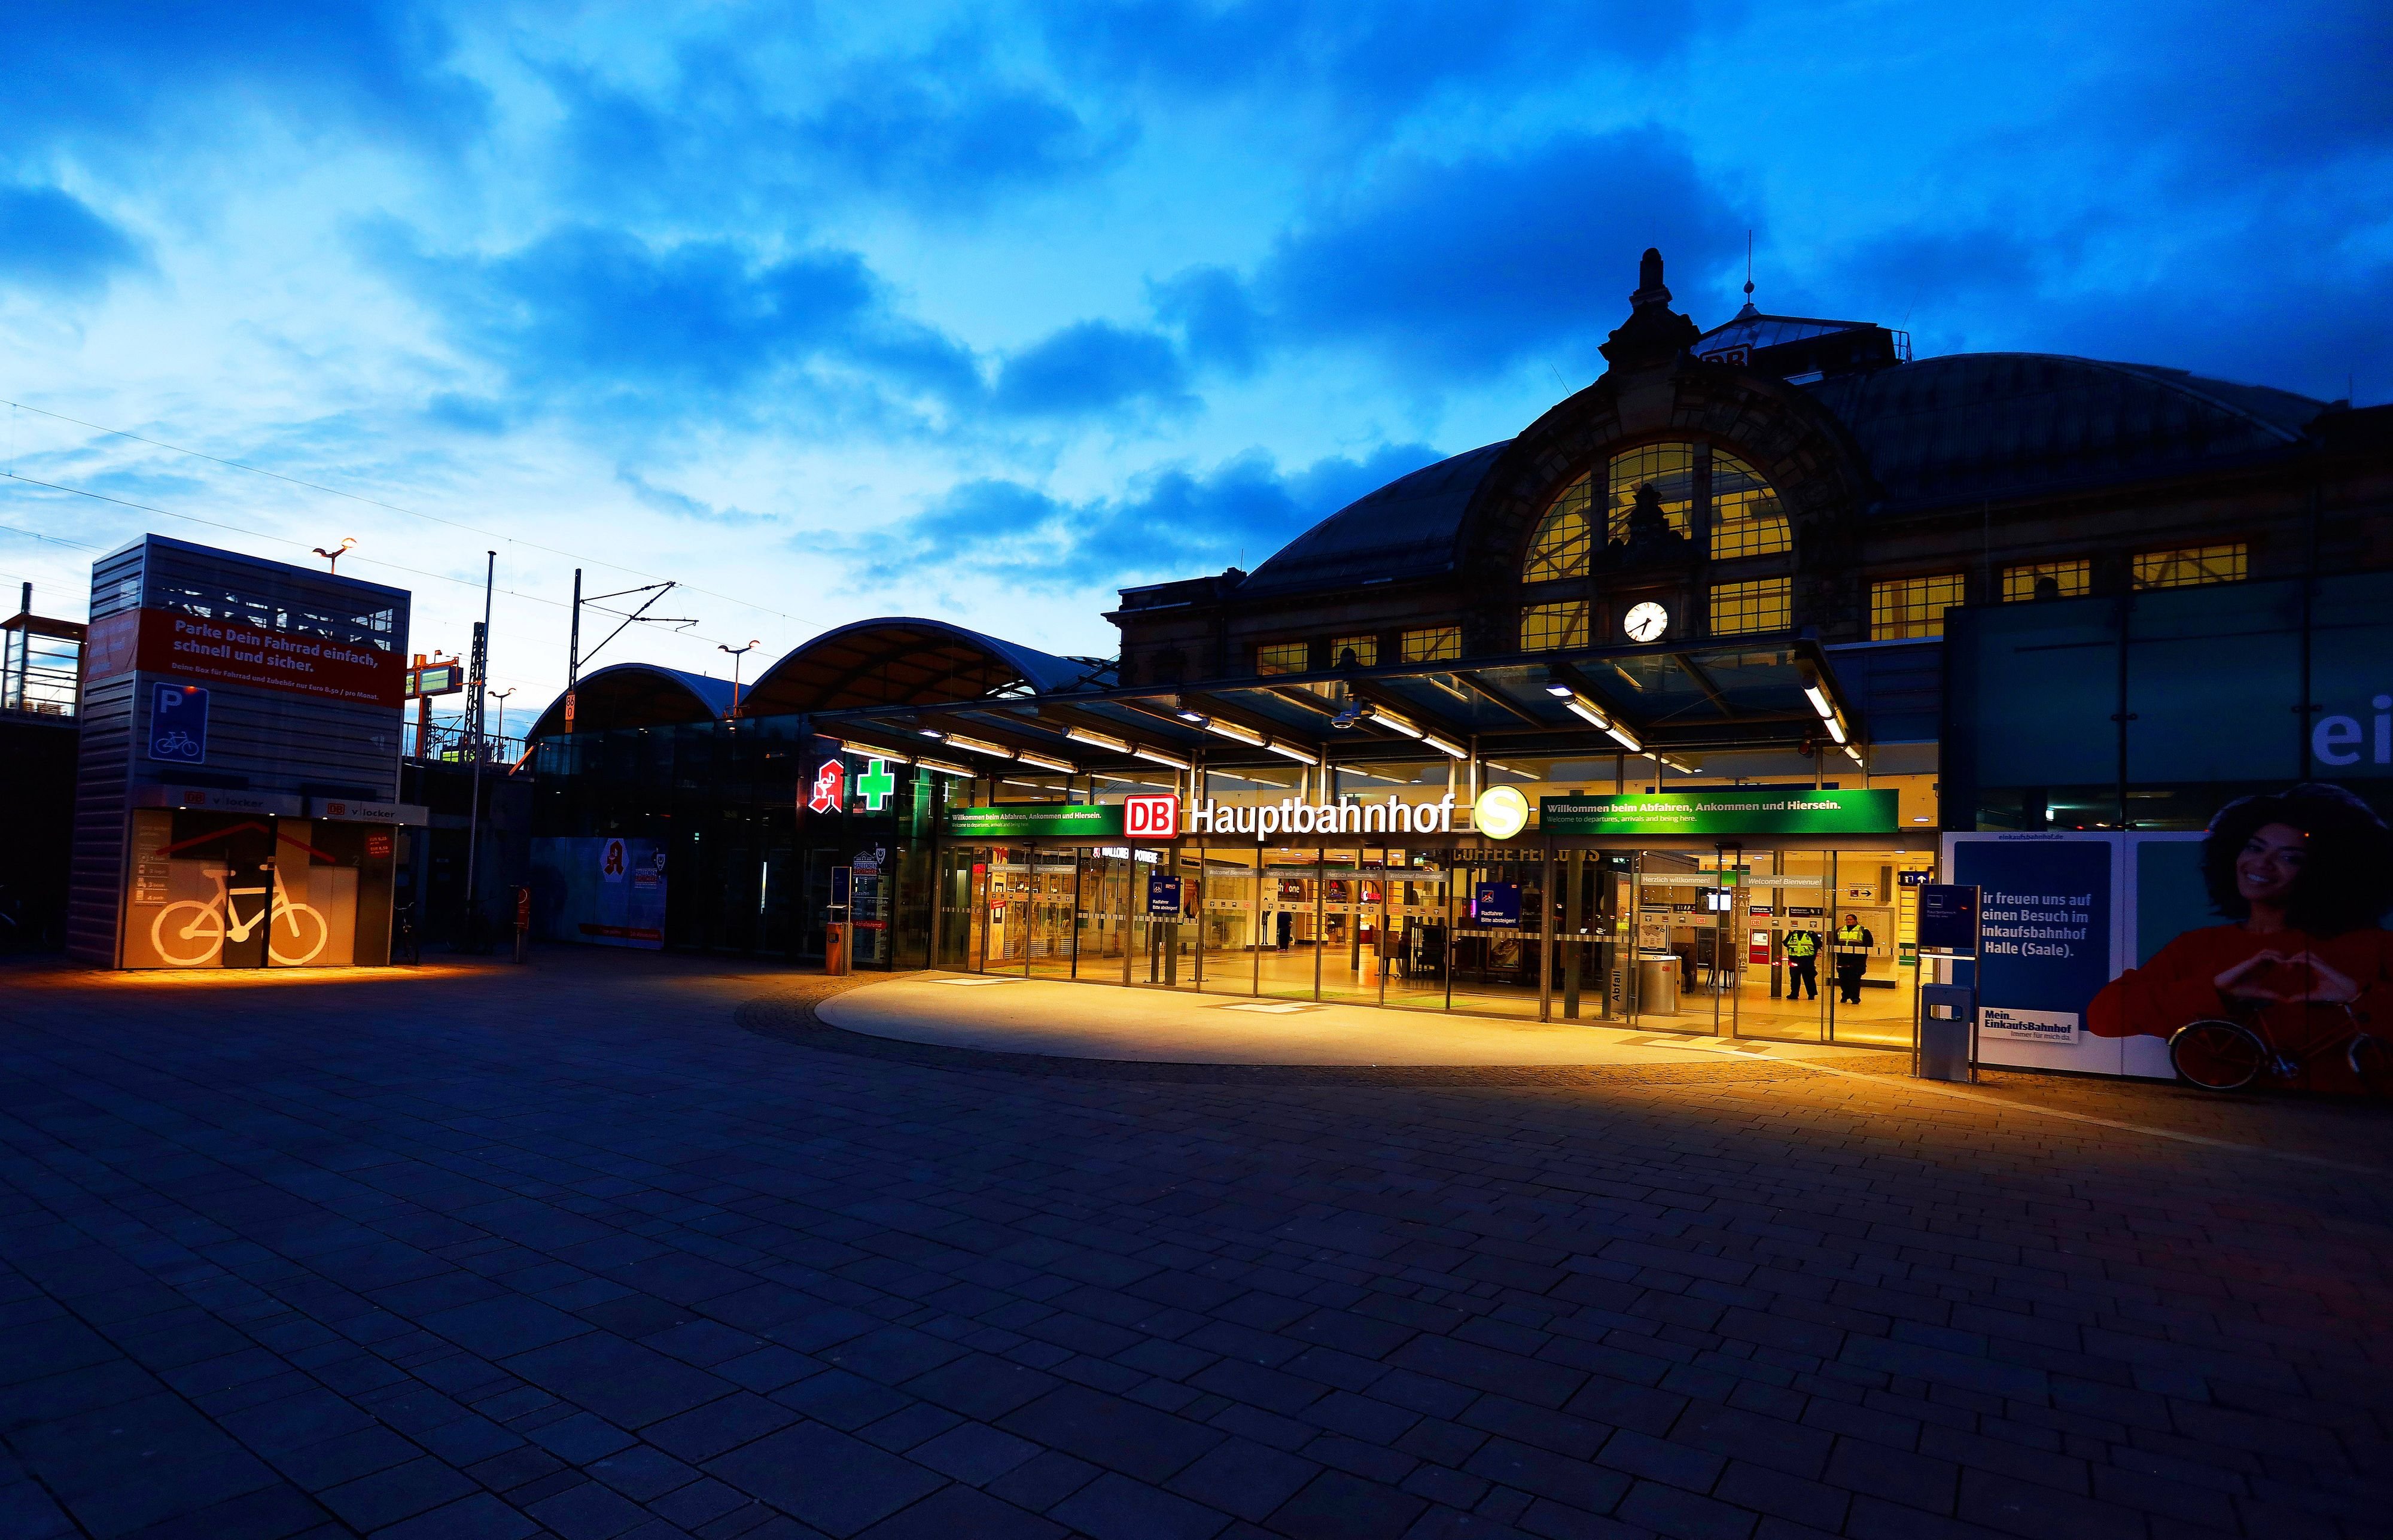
[{"left": 86, "top": 610, "right": 407, "bottom": 705}]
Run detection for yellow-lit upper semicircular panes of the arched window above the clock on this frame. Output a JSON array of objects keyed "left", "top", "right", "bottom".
[{"left": 1520, "top": 442, "right": 1792, "bottom": 583}]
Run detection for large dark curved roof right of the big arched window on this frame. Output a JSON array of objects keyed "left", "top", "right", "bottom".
[{"left": 1802, "top": 354, "right": 2326, "bottom": 507}]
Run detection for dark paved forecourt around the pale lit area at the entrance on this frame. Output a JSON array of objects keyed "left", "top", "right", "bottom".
[{"left": 0, "top": 954, "right": 2393, "bottom": 1540}]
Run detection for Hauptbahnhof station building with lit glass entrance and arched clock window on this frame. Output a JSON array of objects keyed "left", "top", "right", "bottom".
[{"left": 529, "top": 251, "right": 2393, "bottom": 1045}]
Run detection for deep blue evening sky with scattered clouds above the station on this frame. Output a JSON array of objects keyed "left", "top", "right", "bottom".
[{"left": 0, "top": 0, "right": 2393, "bottom": 710}]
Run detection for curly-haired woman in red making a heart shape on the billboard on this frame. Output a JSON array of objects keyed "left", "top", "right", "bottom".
[{"left": 2087, "top": 782, "right": 2393, "bottom": 1091}]
